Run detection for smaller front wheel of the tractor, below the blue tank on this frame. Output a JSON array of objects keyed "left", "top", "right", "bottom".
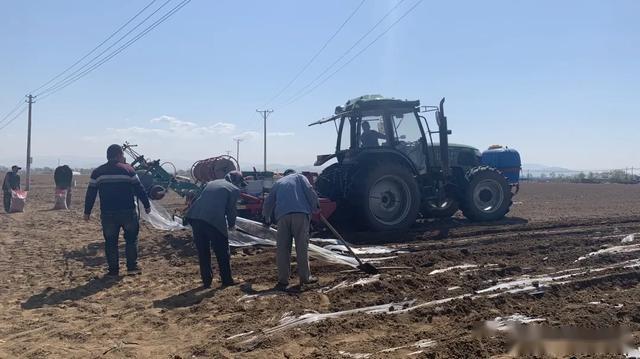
[{"left": 462, "top": 166, "right": 512, "bottom": 221}]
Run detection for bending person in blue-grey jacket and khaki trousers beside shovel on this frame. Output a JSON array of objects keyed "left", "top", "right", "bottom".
[{"left": 262, "top": 169, "right": 319, "bottom": 290}]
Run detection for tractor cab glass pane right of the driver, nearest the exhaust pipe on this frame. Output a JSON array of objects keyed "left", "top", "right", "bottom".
[{"left": 392, "top": 112, "right": 426, "bottom": 173}]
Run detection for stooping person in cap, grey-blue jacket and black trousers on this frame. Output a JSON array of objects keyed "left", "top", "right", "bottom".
[{"left": 185, "top": 171, "right": 246, "bottom": 288}]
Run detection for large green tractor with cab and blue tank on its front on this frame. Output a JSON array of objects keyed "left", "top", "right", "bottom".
[{"left": 309, "top": 95, "right": 521, "bottom": 231}]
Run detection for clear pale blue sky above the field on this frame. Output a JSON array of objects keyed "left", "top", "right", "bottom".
[{"left": 0, "top": 0, "right": 640, "bottom": 169}]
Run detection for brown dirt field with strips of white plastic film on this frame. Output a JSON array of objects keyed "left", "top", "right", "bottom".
[{"left": 0, "top": 177, "right": 640, "bottom": 358}]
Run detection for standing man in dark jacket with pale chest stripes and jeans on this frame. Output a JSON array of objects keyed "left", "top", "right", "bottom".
[{"left": 84, "top": 145, "right": 151, "bottom": 276}]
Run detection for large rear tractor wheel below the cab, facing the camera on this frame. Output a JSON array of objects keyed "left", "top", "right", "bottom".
[{"left": 352, "top": 162, "right": 420, "bottom": 231}]
